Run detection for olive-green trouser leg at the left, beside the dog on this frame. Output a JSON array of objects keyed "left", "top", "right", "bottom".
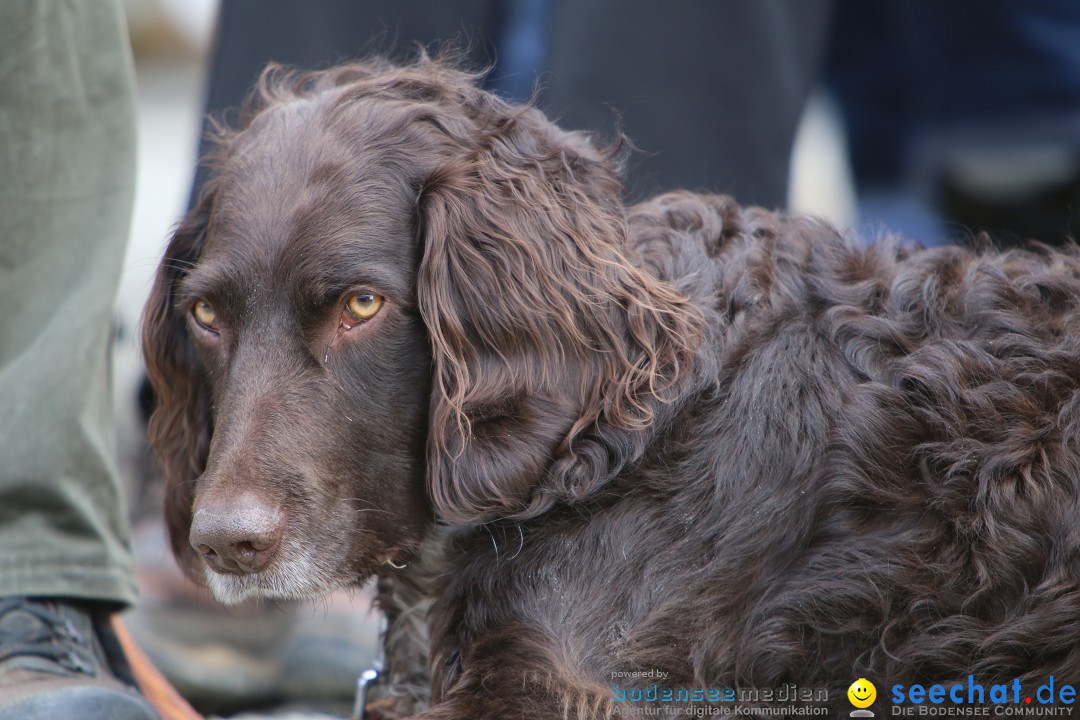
[{"left": 0, "top": 0, "right": 135, "bottom": 603}]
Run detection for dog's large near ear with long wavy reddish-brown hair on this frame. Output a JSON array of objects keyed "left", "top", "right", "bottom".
[{"left": 417, "top": 91, "right": 700, "bottom": 522}]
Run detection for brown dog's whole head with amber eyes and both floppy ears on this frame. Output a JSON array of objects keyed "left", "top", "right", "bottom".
[{"left": 144, "top": 59, "right": 698, "bottom": 601}]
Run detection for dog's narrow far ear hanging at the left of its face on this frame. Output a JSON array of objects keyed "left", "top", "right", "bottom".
[{"left": 143, "top": 185, "right": 213, "bottom": 582}]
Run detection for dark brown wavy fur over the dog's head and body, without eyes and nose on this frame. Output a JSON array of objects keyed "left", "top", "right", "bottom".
[{"left": 145, "top": 59, "right": 1080, "bottom": 719}]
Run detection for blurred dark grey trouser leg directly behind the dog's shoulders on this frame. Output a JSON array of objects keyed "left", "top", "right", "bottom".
[{"left": 543, "top": 0, "right": 831, "bottom": 207}]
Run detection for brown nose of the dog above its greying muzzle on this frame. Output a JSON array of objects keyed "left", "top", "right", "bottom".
[{"left": 189, "top": 493, "right": 284, "bottom": 574}]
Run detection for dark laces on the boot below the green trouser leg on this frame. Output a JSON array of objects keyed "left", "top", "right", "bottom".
[{"left": 0, "top": 598, "right": 97, "bottom": 676}]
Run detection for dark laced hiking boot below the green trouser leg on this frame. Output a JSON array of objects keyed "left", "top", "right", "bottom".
[{"left": 0, "top": 598, "right": 159, "bottom": 720}]
